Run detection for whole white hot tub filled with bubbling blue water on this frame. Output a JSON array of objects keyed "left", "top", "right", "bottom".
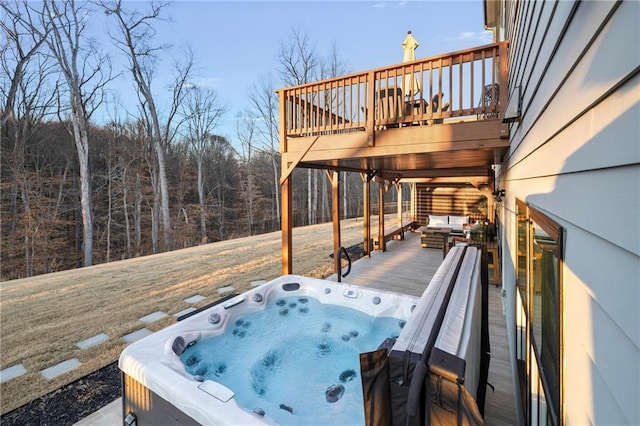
[{"left": 119, "top": 275, "right": 419, "bottom": 425}]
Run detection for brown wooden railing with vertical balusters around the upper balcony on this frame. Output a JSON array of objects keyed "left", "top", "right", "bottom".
[{"left": 278, "top": 42, "right": 507, "bottom": 137}]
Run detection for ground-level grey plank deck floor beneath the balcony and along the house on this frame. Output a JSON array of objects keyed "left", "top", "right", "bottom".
[{"left": 329, "top": 232, "right": 517, "bottom": 425}]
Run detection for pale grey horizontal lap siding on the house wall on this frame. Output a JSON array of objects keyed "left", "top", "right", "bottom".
[{"left": 498, "top": 1, "right": 640, "bottom": 424}]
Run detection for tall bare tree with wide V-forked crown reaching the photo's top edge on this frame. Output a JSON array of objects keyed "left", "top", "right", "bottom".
[{"left": 100, "top": 0, "right": 193, "bottom": 250}]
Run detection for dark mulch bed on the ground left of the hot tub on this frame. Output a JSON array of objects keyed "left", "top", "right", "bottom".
[{"left": 0, "top": 362, "right": 122, "bottom": 426}]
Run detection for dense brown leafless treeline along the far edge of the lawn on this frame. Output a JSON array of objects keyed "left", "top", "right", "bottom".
[{"left": 1, "top": 122, "right": 376, "bottom": 280}]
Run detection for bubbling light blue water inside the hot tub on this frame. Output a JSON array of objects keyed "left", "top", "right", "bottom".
[{"left": 180, "top": 296, "right": 404, "bottom": 424}]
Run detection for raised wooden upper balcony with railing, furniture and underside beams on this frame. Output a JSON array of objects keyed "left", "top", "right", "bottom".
[{"left": 278, "top": 42, "right": 509, "bottom": 182}]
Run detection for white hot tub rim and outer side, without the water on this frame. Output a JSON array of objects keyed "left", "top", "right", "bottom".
[{"left": 118, "top": 275, "right": 419, "bottom": 425}]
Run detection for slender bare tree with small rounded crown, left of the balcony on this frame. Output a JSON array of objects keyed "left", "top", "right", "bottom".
[{"left": 182, "top": 86, "right": 227, "bottom": 244}]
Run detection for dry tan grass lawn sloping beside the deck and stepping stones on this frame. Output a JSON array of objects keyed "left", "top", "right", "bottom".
[{"left": 0, "top": 219, "right": 377, "bottom": 414}]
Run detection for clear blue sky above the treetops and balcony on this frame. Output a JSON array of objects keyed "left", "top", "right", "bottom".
[{"left": 100, "top": 0, "right": 492, "bottom": 138}]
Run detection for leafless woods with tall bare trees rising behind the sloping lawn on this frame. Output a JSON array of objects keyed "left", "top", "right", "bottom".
[{"left": 0, "top": 0, "right": 394, "bottom": 280}]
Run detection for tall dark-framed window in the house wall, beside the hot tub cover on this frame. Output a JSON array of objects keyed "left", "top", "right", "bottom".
[{"left": 516, "top": 200, "right": 563, "bottom": 425}]
